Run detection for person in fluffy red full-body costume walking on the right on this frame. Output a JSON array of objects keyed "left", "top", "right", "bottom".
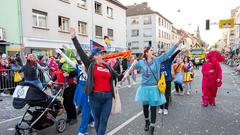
[{"left": 202, "top": 51, "right": 224, "bottom": 107}]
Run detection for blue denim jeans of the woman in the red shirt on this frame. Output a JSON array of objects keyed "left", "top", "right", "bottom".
[{"left": 90, "top": 92, "right": 112, "bottom": 135}]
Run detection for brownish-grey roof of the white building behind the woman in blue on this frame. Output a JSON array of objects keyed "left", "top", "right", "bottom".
[{"left": 126, "top": 2, "right": 173, "bottom": 24}]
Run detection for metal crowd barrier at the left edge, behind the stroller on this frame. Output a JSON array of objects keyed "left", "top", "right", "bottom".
[{"left": 0, "top": 69, "right": 21, "bottom": 91}]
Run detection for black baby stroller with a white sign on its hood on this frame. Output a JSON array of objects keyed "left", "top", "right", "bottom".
[{"left": 13, "top": 82, "right": 66, "bottom": 135}]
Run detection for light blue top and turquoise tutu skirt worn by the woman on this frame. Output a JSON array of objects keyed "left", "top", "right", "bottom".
[{"left": 135, "top": 46, "right": 176, "bottom": 106}]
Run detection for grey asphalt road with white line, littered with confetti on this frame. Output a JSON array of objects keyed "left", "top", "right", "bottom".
[{"left": 0, "top": 65, "right": 240, "bottom": 135}]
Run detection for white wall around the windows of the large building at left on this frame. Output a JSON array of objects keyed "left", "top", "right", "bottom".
[{"left": 22, "top": 0, "right": 126, "bottom": 51}]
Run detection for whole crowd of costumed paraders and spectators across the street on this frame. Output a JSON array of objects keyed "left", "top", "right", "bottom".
[{"left": 0, "top": 28, "right": 230, "bottom": 135}]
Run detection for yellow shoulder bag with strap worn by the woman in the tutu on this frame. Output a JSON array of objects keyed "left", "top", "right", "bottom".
[{"left": 147, "top": 62, "right": 167, "bottom": 94}]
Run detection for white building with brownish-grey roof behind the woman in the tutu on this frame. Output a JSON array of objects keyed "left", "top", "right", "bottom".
[{"left": 127, "top": 2, "right": 172, "bottom": 53}]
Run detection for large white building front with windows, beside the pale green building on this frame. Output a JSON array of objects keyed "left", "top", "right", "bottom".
[{"left": 21, "top": 0, "right": 126, "bottom": 54}]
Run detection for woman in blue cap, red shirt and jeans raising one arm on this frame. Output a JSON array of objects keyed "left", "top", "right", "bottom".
[{"left": 70, "top": 28, "right": 119, "bottom": 135}]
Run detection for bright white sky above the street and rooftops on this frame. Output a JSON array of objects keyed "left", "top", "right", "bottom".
[{"left": 119, "top": 0, "right": 240, "bottom": 45}]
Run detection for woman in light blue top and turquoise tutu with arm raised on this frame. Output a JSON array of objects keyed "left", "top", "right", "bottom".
[{"left": 123, "top": 38, "right": 183, "bottom": 135}]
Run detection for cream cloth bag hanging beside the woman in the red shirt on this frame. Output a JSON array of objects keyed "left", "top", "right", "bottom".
[{"left": 111, "top": 87, "right": 121, "bottom": 114}]
